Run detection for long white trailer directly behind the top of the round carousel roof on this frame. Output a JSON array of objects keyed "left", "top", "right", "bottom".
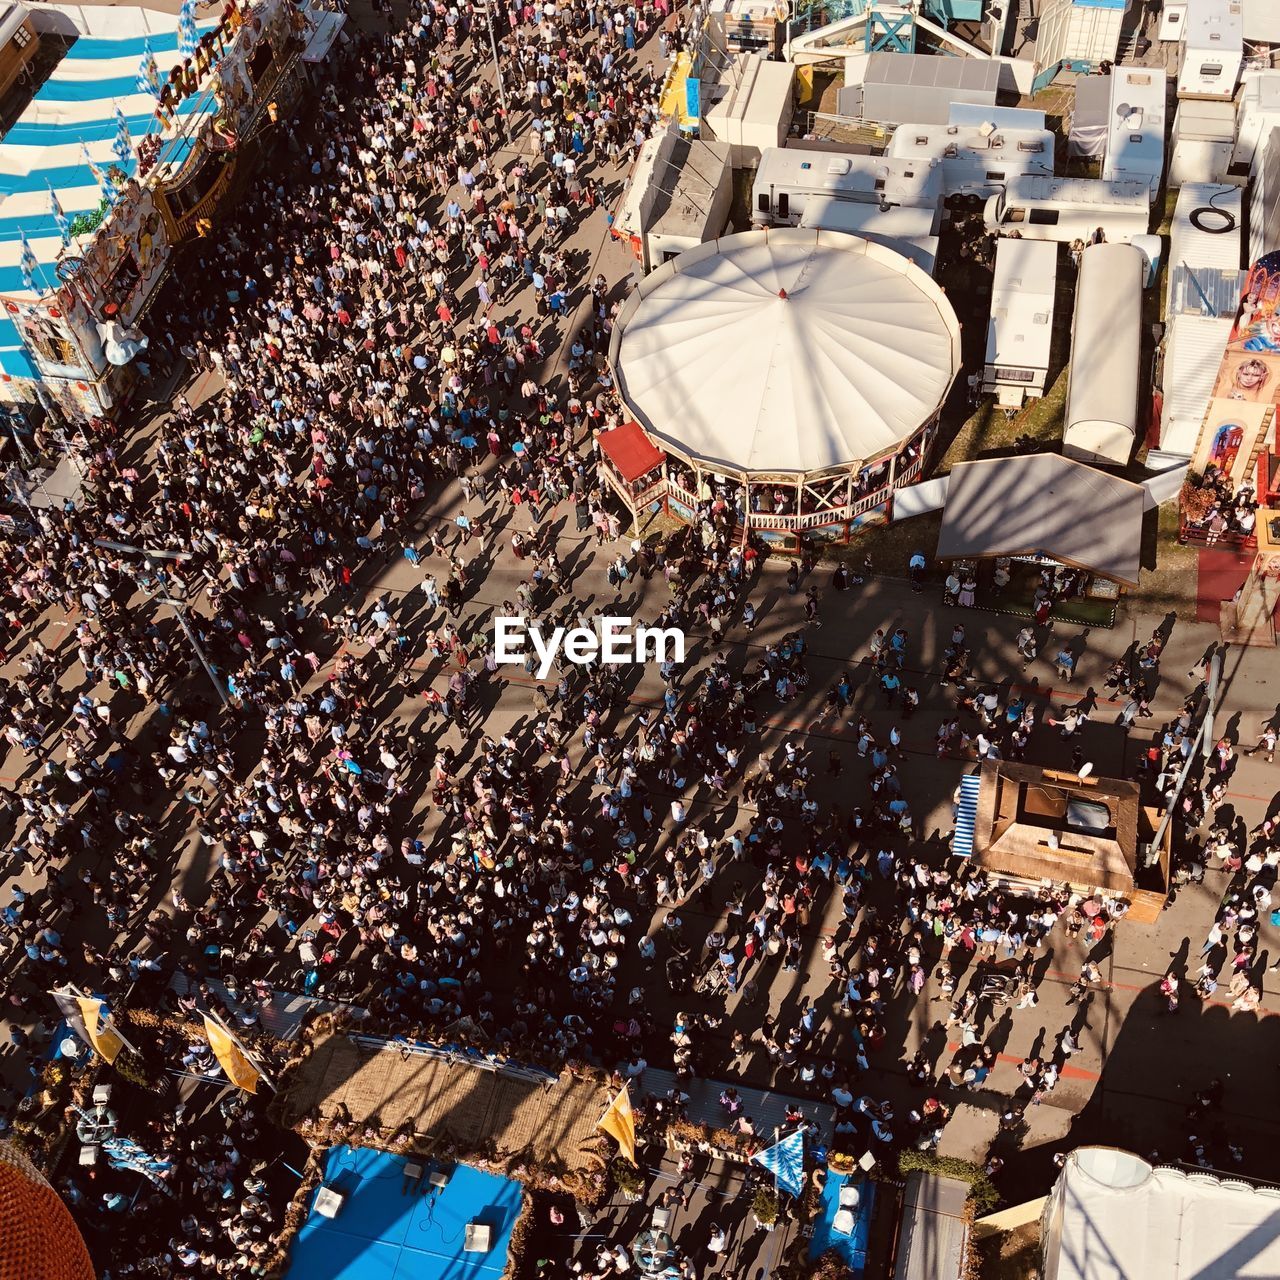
[{"left": 751, "top": 147, "right": 942, "bottom": 233}]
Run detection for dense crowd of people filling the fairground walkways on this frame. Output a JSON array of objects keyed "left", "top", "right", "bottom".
[{"left": 0, "top": 0, "right": 1280, "bottom": 1277}]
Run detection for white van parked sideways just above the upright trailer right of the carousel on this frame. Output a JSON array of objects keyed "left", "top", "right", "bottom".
[{"left": 983, "top": 175, "right": 1151, "bottom": 244}]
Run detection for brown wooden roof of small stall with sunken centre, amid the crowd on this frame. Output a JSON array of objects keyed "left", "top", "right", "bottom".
[{"left": 973, "top": 760, "right": 1142, "bottom": 893}]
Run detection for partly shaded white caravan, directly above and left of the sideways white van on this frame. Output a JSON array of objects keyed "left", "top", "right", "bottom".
[{"left": 886, "top": 120, "right": 1053, "bottom": 207}]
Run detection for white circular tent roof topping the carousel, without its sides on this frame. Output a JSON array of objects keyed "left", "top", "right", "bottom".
[{"left": 609, "top": 228, "right": 960, "bottom": 472}]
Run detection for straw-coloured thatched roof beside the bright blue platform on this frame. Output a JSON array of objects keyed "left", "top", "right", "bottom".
[{"left": 283, "top": 1033, "right": 609, "bottom": 1171}]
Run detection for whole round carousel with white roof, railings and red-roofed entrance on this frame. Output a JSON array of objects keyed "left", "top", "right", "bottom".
[{"left": 600, "top": 228, "right": 960, "bottom": 550}]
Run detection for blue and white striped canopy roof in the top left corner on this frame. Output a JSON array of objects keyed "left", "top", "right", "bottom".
[{"left": 0, "top": 15, "right": 216, "bottom": 378}]
